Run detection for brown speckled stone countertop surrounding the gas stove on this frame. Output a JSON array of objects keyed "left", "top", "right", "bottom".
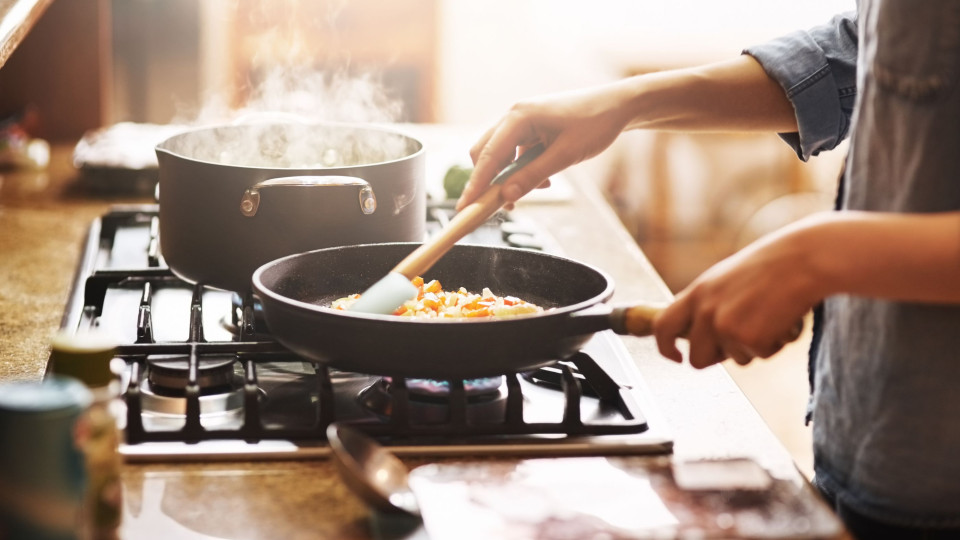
[{"left": 0, "top": 126, "right": 840, "bottom": 538}]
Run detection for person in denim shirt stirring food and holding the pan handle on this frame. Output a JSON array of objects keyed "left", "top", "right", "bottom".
[{"left": 458, "top": 0, "right": 960, "bottom": 538}]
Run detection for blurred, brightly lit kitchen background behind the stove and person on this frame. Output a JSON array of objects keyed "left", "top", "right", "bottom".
[{"left": 0, "top": 0, "right": 855, "bottom": 474}]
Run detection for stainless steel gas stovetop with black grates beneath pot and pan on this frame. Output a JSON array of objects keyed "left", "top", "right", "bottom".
[{"left": 50, "top": 204, "right": 672, "bottom": 461}]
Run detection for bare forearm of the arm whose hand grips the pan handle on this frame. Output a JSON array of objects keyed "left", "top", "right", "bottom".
[{"left": 801, "top": 212, "right": 960, "bottom": 303}]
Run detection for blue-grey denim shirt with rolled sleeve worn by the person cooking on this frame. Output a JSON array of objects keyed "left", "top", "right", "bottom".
[{"left": 744, "top": 0, "right": 960, "bottom": 527}]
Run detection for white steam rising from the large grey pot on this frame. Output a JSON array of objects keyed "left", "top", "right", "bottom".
[{"left": 171, "top": 0, "right": 417, "bottom": 169}]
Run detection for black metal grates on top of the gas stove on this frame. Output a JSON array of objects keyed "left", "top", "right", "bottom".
[{"left": 62, "top": 206, "right": 647, "bottom": 445}]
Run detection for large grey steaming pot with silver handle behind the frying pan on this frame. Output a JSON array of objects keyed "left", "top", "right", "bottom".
[{"left": 156, "top": 122, "right": 426, "bottom": 294}]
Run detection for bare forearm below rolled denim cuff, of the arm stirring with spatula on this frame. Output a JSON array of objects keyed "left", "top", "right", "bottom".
[{"left": 611, "top": 55, "right": 797, "bottom": 132}]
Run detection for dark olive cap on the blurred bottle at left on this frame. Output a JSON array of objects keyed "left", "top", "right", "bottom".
[{"left": 50, "top": 331, "right": 117, "bottom": 388}]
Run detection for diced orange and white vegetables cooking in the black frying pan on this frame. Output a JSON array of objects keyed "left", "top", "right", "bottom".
[{"left": 330, "top": 276, "right": 543, "bottom": 319}]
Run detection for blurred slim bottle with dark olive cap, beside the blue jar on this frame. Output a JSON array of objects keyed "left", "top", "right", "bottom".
[{"left": 50, "top": 332, "right": 123, "bottom": 540}]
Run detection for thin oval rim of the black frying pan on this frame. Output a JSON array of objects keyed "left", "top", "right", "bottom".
[{"left": 251, "top": 242, "right": 615, "bottom": 326}]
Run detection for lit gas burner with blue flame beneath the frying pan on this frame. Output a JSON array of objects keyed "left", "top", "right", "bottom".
[{"left": 357, "top": 377, "right": 507, "bottom": 424}]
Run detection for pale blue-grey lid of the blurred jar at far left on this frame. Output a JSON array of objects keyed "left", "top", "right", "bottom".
[{"left": 0, "top": 375, "right": 93, "bottom": 416}]
